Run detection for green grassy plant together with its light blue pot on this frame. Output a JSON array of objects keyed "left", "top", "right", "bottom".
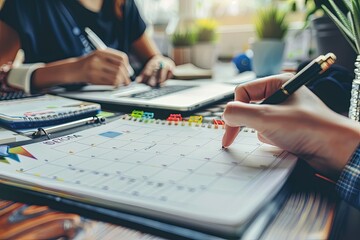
[{"left": 251, "top": 6, "right": 289, "bottom": 77}]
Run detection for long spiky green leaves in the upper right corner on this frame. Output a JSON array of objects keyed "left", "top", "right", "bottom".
[{"left": 322, "top": 0, "right": 360, "bottom": 54}]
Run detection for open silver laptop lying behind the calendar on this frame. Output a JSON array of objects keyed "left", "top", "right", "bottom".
[{"left": 57, "top": 80, "right": 235, "bottom": 112}]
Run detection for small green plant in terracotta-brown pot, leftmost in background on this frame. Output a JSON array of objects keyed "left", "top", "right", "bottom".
[{"left": 171, "top": 29, "right": 196, "bottom": 65}]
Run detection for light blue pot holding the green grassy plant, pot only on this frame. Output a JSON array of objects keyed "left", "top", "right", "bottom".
[{"left": 251, "top": 39, "right": 285, "bottom": 77}]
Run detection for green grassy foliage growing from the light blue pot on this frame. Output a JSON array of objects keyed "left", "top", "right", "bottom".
[{"left": 255, "top": 6, "right": 289, "bottom": 40}]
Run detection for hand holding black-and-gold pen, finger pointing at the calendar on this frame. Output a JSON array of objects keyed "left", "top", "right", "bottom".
[{"left": 223, "top": 52, "right": 360, "bottom": 180}]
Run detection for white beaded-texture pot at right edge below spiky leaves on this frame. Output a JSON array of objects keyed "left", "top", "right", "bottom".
[{"left": 349, "top": 55, "right": 360, "bottom": 122}]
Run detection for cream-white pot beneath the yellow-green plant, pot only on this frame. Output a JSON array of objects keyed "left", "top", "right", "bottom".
[{"left": 191, "top": 43, "right": 217, "bottom": 69}]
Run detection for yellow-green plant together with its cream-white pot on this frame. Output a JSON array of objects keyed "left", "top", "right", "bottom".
[{"left": 192, "top": 19, "right": 218, "bottom": 69}]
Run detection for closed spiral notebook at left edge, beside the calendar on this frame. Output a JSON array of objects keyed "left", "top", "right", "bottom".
[{"left": 0, "top": 94, "right": 101, "bottom": 129}]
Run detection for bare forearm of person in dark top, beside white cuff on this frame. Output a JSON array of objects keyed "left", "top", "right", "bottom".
[{"left": 32, "top": 58, "right": 83, "bottom": 90}]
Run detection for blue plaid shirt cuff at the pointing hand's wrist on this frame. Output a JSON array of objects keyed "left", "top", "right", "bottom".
[{"left": 336, "top": 145, "right": 360, "bottom": 209}]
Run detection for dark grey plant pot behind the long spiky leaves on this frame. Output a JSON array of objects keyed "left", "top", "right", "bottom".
[{"left": 311, "top": 16, "right": 356, "bottom": 71}]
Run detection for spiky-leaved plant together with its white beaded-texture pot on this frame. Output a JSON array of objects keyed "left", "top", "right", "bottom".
[{"left": 322, "top": 0, "right": 360, "bottom": 122}]
